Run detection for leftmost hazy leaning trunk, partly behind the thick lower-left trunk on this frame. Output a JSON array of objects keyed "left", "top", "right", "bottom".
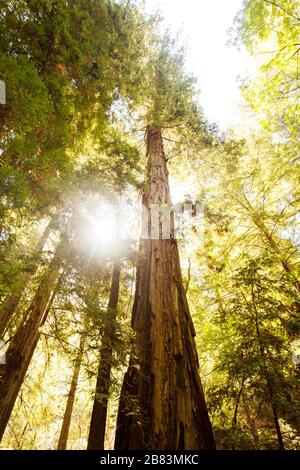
[{"left": 0, "top": 213, "right": 56, "bottom": 338}]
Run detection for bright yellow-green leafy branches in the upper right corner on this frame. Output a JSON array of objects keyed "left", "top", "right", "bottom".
[{"left": 236, "top": 0, "right": 300, "bottom": 140}]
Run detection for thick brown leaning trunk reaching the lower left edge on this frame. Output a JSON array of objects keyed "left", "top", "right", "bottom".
[{"left": 0, "top": 243, "right": 62, "bottom": 440}]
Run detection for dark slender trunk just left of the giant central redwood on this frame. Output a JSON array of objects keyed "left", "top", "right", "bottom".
[{"left": 87, "top": 260, "right": 121, "bottom": 450}]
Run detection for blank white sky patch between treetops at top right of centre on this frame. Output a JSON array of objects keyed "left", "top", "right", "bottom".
[{"left": 145, "top": 0, "right": 253, "bottom": 129}]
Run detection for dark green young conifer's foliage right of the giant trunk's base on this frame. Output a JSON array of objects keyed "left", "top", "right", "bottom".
[{"left": 203, "top": 254, "right": 299, "bottom": 448}]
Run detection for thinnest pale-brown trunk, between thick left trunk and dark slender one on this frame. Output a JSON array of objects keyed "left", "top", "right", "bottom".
[{"left": 57, "top": 331, "right": 86, "bottom": 450}]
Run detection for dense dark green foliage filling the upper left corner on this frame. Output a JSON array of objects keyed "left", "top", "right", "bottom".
[{"left": 0, "top": 0, "right": 147, "bottom": 222}]
